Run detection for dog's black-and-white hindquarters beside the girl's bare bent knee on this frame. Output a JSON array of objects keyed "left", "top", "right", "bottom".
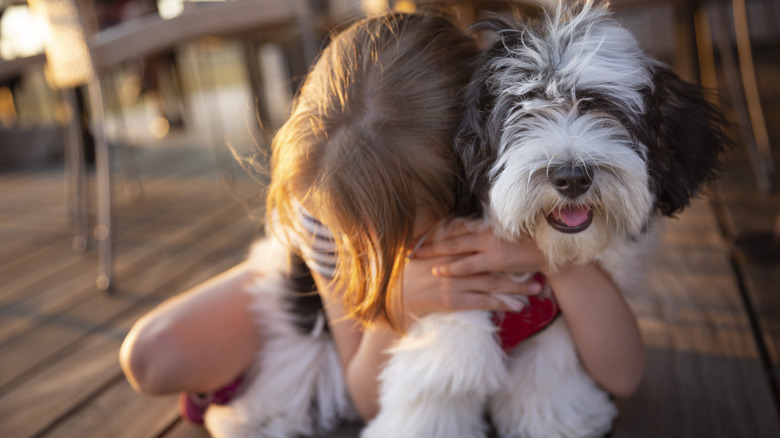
[{"left": 205, "top": 236, "right": 358, "bottom": 438}]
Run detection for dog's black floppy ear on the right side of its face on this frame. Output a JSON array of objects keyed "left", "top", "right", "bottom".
[{"left": 640, "top": 64, "right": 729, "bottom": 216}]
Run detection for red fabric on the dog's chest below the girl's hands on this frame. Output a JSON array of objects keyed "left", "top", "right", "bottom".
[{"left": 493, "top": 273, "right": 560, "bottom": 353}]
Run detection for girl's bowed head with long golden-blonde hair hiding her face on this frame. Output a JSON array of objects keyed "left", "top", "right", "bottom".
[{"left": 267, "top": 13, "right": 478, "bottom": 327}]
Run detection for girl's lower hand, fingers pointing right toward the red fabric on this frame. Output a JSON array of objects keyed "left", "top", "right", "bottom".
[{"left": 403, "top": 250, "right": 542, "bottom": 322}]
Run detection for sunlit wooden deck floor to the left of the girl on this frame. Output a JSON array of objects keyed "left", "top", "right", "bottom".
[{"left": 0, "top": 138, "right": 266, "bottom": 437}]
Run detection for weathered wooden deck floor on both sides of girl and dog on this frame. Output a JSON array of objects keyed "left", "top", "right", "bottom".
[{"left": 0, "top": 1, "right": 780, "bottom": 438}]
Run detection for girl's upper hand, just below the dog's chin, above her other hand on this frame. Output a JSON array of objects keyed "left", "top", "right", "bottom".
[{"left": 414, "top": 220, "right": 548, "bottom": 277}]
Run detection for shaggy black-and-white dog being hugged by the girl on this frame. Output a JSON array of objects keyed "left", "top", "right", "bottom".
[{"left": 207, "top": 1, "right": 725, "bottom": 438}]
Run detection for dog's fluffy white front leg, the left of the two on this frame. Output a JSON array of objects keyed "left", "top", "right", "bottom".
[{"left": 362, "top": 311, "right": 506, "bottom": 438}]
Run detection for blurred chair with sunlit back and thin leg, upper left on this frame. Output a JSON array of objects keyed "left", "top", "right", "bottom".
[{"left": 30, "top": 0, "right": 317, "bottom": 290}]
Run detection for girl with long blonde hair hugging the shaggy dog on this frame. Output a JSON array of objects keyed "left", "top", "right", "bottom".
[{"left": 120, "top": 7, "right": 644, "bottom": 434}]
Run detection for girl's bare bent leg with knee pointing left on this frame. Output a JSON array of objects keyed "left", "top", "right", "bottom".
[{"left": 119, "top": 263, "right": 261, "bottom": 395}]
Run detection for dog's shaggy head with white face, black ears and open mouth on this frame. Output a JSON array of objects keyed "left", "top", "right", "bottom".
[{"left": 456, "top": 1, "right": 724, "bottom": 264}]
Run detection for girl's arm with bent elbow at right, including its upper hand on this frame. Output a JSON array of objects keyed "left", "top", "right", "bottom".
[{"left": 418, "top": 222, "right": 646, "bottom": 397}]
